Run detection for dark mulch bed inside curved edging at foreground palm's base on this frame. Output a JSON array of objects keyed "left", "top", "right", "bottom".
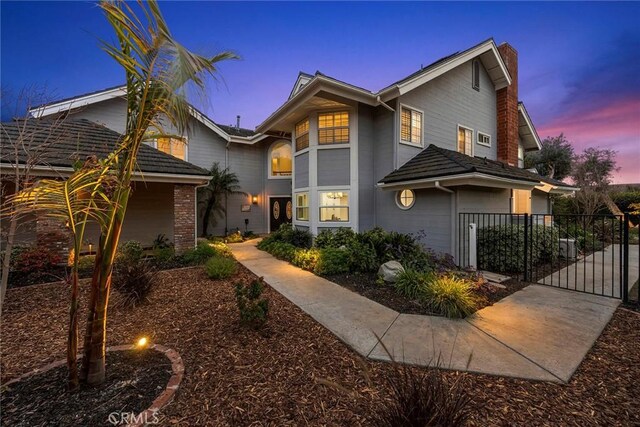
[{"left": 0, "top": 350, "right": 172, "bottom": 426}]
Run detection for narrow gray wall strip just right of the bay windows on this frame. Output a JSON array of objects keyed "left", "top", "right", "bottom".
[{"left": 358, "top": 105, "right": 375, "bottom": 231}]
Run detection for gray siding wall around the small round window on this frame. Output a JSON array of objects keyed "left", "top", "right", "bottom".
[{"left": 377, "top": 190, "right": 453, "bottom": 253}]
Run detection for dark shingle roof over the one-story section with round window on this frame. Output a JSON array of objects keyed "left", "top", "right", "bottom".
[{"left": 379, "top": 144, "right": 569, "bottom": 187}]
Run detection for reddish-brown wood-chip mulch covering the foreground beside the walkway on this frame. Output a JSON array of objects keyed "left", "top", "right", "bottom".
[{"left": 0, "top": 268, "right": 640, "bottom": 426}]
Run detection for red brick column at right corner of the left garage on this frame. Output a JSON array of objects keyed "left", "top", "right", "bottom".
[{"left": 173, "top": 184, "right": 196, "bottom": 253}]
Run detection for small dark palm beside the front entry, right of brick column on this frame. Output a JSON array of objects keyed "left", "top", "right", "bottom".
[{"left": 198, "top": 162, "right": 247, "bottom": 237}]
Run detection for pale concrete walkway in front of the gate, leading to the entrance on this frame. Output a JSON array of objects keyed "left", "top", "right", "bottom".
[{"left": 229, "top": 241, "right": 619, "bottom": 382}]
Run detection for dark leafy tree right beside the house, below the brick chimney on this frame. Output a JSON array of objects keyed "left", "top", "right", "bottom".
[{"left": 524, "top": 133, "right": 574, "bottom": 180}]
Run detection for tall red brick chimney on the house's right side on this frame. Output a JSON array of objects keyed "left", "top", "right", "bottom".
[{"left": 496, "top": 43, "right": 518, "bottom": 166}]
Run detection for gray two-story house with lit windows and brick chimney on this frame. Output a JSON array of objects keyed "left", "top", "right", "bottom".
[{"left": 3, "top": 39, "right": 573, "bottom": 260}]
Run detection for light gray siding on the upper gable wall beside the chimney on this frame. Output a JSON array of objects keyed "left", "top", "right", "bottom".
[{"left": 398, "top": 57, "right": 497, "bottom": 166}]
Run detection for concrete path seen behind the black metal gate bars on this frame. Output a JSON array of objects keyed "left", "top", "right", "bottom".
[{"left": 538, "top": 244, "right": 640, "bottom": 298}]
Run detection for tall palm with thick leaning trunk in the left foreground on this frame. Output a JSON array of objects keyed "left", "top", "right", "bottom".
[{"left": 80, "top": 0, "right": 237, "bottom": 385}]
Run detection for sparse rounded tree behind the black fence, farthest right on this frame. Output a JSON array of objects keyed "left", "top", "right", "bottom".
[{"left": 571, "top": 148, "right": 619, "bottom": 221}]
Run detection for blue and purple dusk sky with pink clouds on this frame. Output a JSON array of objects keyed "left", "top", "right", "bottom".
[{"left": 0, "top": 1, "right": 640, "bottom": 182}]
